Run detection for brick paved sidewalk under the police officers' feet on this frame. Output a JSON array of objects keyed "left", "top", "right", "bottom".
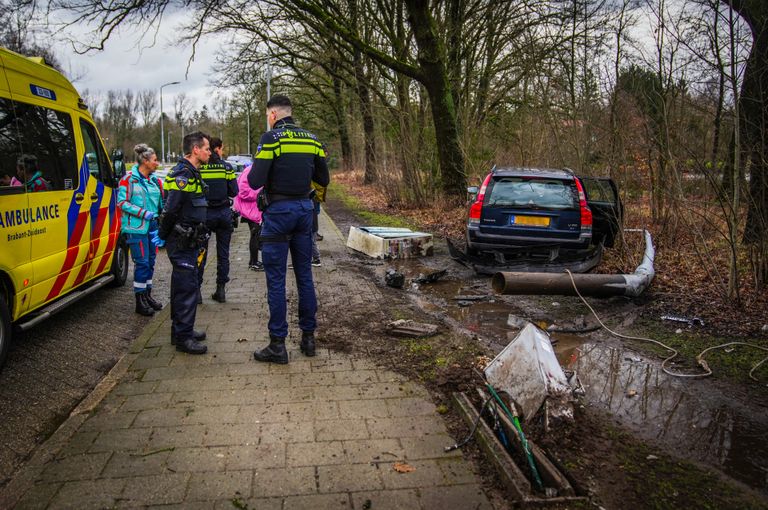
[{"left": 0, "top": 209, "right": 491, "bottom": 510}]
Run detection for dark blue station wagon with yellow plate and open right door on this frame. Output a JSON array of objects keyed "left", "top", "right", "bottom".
[{"left": 466, "top": 167, "right": 623, "bottom": 272}]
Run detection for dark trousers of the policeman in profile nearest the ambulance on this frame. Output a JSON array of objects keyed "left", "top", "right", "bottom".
[{"left": 165, "top": 232, "right": 200, "bottom": 342}]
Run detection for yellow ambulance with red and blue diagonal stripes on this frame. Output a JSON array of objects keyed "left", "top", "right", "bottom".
[{"left": 0, "top": 48, "right": 128, "bottom": 366}]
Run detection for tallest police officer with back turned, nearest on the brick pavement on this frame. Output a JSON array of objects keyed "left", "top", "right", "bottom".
[{"left": 248, "top": 95, "right": 330, "bottom": 364}]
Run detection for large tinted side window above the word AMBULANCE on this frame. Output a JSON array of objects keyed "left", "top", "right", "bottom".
[{"left": 0, "top": 98, "right": 78, "bottom": 191}]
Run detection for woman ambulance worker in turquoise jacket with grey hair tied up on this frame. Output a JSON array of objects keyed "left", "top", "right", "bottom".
[{"left": 117, "top": 143, "right": 163, "bottom": 316}]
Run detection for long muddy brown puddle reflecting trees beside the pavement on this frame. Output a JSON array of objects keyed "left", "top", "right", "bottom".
[{"left": 377, "top": 261, "right": 768, "bottom": 491}]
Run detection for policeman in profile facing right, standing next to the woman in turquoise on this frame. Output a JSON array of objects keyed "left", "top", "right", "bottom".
[{"left": 158, "top": 131, "right": 211, "bottom": 354}]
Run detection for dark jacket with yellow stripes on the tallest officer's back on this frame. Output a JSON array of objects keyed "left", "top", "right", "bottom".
[{"left": 248, "top": 117, "right": 330, "bottom": 201}]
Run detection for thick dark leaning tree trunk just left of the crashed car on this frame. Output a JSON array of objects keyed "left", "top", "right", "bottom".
[{"left": 405, "top": 0, "right": 467, "bottom": 196}]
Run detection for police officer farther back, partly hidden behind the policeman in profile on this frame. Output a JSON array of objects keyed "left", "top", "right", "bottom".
[{"left": 198, "top": 137, "right": 237, "bottom": 303}]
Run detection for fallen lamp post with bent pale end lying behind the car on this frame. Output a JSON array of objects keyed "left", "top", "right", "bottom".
[{"left": 491, "top": 230, "right": 656, "bottom": 297}]
